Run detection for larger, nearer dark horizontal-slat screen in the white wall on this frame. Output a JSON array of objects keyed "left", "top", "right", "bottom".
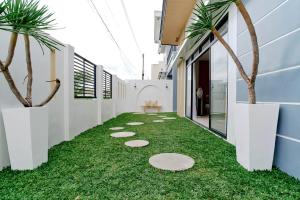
[{"left": 74, "top": 53, "right": 96, "bottom": 98}]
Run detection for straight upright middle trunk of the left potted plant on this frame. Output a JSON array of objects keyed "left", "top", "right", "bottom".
[{"left": 24, "top": 34, "right": 33, "bottom": 106}]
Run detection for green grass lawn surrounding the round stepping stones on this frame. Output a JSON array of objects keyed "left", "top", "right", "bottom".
[{"left": 0, "top": 113, "right": 300, "bottom": 200}]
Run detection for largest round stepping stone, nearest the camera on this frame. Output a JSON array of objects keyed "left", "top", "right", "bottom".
[{"left": 149, "top": 153, "right": 195, "bottom": 171}]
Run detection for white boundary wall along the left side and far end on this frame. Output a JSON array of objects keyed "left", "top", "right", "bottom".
[{"left": 0, "top": 31, "right": 173, "bottom": 169}]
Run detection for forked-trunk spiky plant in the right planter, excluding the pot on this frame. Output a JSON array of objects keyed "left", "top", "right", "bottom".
[{"left": 187, "top": 0, "right": 259, "bottom": 104}]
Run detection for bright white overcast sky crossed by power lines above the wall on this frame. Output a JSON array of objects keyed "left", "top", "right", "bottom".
[{"left": 41, "top": 0, "right": 162, "bottom": 79}]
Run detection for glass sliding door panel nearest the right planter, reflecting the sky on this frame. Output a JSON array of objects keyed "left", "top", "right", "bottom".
[{"left": 210, "top": 34, "right": 228, "bottom": 136}]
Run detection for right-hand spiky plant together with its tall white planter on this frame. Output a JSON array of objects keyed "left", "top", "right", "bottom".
[{"left": 187, "top": 0, "right": 279, "bottom": 171}]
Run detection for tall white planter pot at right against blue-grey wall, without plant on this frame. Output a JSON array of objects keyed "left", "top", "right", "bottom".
[{"left": 235, "top": 104, "right": 279, "bottom": 171}]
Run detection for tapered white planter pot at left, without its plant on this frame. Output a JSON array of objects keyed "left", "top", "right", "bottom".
[{"left": 2, "top": 107, "right": 48, "bottom": 170}]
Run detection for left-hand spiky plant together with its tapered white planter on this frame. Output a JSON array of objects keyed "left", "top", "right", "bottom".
[{"left": 0, "top": 0, "right": 63, "bottom": 170}]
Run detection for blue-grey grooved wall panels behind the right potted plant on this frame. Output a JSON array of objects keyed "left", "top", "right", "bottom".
[{"left": 237, "top": 0, "right": 300, "bottom": 178}]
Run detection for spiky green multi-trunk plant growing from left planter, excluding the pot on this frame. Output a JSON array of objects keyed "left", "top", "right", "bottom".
[{"left": 0, "top": 0, "right": 63, "bottom": 107}]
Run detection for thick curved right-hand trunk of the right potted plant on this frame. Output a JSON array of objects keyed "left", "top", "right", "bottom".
[{"left": 235, "top": 0, "right": 259, "bottom": 84}]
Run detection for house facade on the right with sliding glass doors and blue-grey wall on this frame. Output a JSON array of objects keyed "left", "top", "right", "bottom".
[{"left": 159, "top": 0, "right": 300, "bottom": 178}]
